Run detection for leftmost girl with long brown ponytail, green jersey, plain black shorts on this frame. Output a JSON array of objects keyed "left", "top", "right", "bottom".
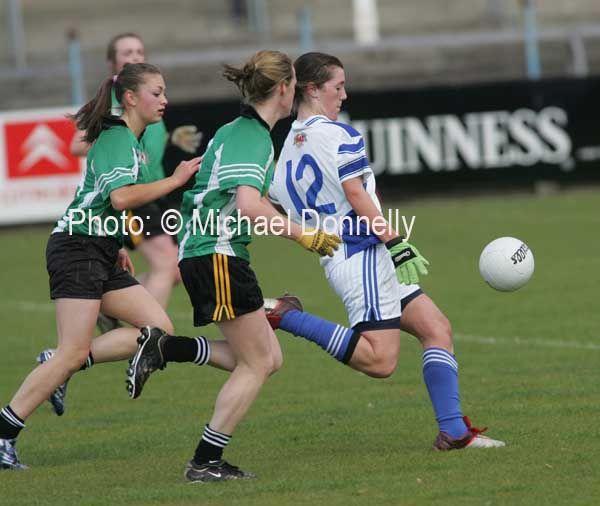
[{"left": 0, "top": 63, "right": 200, "bottom": 469}]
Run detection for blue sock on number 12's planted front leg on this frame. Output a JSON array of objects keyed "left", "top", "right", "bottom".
[{"left": 423, "top": 348, "right": 467, "bottom": 438}]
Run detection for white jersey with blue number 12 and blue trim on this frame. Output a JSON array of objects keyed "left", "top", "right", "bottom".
[{"left": 269, "top": 116, "right": 381, "bottom": 264}]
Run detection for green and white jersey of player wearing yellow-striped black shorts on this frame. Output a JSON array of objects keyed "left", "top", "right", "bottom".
[{"left": 179, "top": 107, "right": 274, "bottom": 261}]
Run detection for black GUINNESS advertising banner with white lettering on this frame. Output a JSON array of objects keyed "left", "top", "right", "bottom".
[{"left": 165, "top": 78, "right": 600, "bottom": 201}]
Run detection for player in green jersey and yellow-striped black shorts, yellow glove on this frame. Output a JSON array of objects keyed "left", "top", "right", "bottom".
[{"left": 128, "top": 51, "right": 339, "bottom": 482}]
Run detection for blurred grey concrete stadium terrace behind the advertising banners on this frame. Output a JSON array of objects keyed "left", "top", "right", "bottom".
[{"left": 0, "top": 0, "right": 600, "bottom": 110}]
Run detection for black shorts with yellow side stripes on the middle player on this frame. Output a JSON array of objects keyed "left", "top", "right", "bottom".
[{"left": 179, "top": 253, "right": 264, "bottom": 327}]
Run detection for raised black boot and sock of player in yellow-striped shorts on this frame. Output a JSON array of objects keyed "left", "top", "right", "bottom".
[{"left": 126, "top": 327, "right": 210, "bottom": 399}]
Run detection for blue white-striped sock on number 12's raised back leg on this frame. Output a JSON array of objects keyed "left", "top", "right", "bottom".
[{"left": 279, "top": 310, "right": 360, "bottom": 364}]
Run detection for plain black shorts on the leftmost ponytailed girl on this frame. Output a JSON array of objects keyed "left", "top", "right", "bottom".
[{"left": 46, "top": 232, "right": 138, "bottom": 299}]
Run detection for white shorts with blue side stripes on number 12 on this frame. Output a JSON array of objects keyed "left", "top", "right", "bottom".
[{"left": 324, "top": 244, "right": 421, "bottom": 327}]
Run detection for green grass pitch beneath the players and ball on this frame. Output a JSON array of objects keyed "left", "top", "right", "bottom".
[{"left": 0, "top": 191, "right": 600, "bottom": 506}]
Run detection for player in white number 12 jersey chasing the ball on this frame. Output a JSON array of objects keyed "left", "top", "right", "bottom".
[{"left": 265, "top": 53, "right": 504, "bottom": 450}]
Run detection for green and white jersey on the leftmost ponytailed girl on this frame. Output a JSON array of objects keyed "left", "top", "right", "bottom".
[{"left": 52, "top": 117, "right": 151, "bottom": 244}]
